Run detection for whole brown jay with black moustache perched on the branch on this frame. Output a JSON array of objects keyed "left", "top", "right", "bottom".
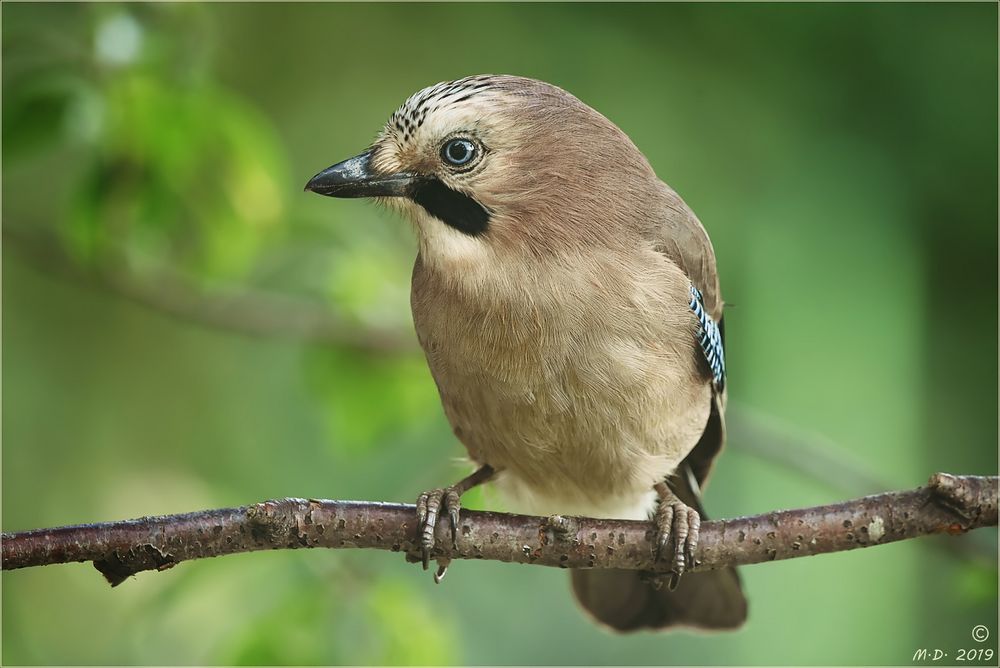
[{"left": 305, "top": 74, "right": 747, "bottom": 632}]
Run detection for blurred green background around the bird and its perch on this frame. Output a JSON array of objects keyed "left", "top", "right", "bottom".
[{"left": 2, "top": 4, "right": 997, "bottom": 664}]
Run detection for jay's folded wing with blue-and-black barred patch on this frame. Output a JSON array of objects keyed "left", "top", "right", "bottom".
[{"left": 651, "top": 186, "right": 726, "bottom": 486}]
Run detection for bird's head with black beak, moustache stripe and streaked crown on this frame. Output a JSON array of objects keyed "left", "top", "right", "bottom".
[{"left": 306, "top": 75, "right": 662, "bottom": 263}]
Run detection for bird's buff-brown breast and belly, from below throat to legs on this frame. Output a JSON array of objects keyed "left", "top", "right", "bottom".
[{"left": 412, "top": 248, "right": 711, "bottom": 517}]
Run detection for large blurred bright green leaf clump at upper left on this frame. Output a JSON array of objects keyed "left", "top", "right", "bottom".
[{"left": 65, "top": 75, "right": 287, "bottom": 279}]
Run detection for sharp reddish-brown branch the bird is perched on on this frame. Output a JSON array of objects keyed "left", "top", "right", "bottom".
[{"left": 2, "top": 473, "right": 998, "bottom": 585}]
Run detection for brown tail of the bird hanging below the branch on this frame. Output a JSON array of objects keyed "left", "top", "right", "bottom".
[{"left": 571, "top": 568, "right": 747, "bottom": 631}]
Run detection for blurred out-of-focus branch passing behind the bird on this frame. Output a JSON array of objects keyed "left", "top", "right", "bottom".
[{"left": 9, "top": 224, "right": 996, "bottom": 560}]
